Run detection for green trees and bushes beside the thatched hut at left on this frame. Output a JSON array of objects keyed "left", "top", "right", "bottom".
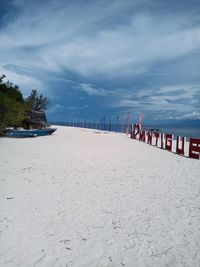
[{"left": 0, "top": 74, "right": 48, "bottom": 134}]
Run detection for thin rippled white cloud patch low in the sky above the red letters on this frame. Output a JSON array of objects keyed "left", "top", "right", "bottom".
[{"left": 111, "top": 84, "right": 200, "bottom": 115}]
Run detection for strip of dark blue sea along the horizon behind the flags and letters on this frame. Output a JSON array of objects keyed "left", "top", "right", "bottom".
[{"left": 51, "top": 121, "right": 200, "bottom": 140}]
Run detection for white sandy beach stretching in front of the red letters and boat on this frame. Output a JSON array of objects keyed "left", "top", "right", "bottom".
[{"left": 0, "top": 127, "right": 200, "bottom": 267}]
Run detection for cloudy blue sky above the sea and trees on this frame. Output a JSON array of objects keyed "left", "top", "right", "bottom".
[{"left": 0, "top": 0, "right": 200, "bottom": 122}]
